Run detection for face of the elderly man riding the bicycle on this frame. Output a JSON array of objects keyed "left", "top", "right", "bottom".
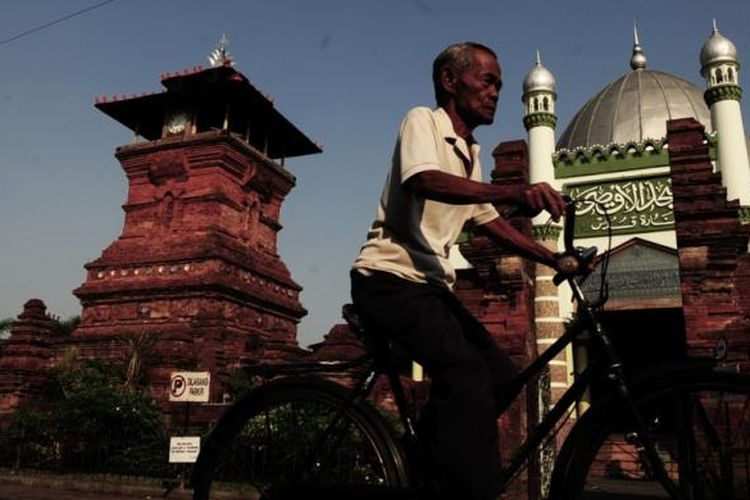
[{"left": 454, "top": 49, "right": 503, "bottom": 128}]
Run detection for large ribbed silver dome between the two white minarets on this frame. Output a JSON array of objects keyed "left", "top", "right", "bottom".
[{"left": 557, "top": 69, "right": 712, "bottom": 149}]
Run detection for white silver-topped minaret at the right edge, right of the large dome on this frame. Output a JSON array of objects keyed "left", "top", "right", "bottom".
[{"left": 700, "top": 20, "right": 750, "bottom": 207}]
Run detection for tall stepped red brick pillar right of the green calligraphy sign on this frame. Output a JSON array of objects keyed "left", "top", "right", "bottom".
[{"left": 667, "top": 118, "right": 750, "bottom": 365}]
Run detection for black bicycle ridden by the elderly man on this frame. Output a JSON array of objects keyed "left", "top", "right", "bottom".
[{"left": 193, "top": 203, "right": 750, "bottom": 500}]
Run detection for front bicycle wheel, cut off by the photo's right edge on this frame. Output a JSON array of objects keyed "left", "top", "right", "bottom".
[{"left": 550, "top": 371, "right": 750, "bottom": 500}]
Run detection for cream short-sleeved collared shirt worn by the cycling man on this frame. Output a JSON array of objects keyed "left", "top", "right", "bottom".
[{"left": 354, "top": 107, "right": 498, "bottom": 288}]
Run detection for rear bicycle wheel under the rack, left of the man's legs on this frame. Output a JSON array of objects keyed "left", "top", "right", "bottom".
[{"left": 193, "top": 379, "right": 407, "bottom": 500}]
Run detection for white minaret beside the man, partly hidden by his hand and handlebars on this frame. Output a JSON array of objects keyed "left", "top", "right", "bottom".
[{"left": 522, "top": 51, "right": 572, "bottom": 413}]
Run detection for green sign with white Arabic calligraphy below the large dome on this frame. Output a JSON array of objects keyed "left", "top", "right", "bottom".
[{"left": 565, "top": 175, "right": 674, "bottom": 237}]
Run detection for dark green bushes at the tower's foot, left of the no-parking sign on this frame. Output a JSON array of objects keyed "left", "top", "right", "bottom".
[{"left": 0, "top": 352, "right": 171, "bottom": 476}]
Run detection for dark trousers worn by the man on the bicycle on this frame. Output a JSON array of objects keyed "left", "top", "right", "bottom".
[{"left": 352, "top": 271, "right": 517, "bottom": 500}]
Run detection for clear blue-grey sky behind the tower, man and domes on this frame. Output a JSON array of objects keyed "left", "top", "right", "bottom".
[{"left": 0, "top": 0, "right": 750, "bottom": 346}]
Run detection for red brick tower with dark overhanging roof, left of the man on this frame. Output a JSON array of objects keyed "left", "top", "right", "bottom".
[{"left": 73, "top": 52, "right": 321, "bottom": 401}]
